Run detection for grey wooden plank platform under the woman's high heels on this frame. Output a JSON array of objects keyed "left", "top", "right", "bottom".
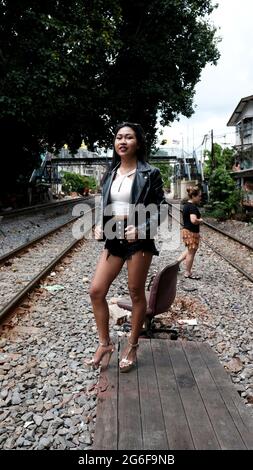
[{"left": 93, "top": 339, "right": 253, "bottom": 450}]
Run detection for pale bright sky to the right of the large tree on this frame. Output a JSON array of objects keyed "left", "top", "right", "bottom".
[{"left": 158, "top": 0, "right": 253, "bottom": 156}]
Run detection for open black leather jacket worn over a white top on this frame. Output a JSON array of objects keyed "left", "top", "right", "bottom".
[{"left": 101, "top": 160, "right": 168, "bottom": 238}]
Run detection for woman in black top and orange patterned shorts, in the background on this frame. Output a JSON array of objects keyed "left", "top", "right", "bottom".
[{"left": 178, "top": 186, "right": 203, "bottom": 279}]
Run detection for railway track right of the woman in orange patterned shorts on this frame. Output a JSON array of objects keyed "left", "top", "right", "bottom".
[{"left": 169, "top": 203, "right": 253, "bottom": 282}]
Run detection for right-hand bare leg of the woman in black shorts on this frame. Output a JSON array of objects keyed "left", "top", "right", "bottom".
[{"left": 122, "top": 251, "right": 153, "bottom": 361}]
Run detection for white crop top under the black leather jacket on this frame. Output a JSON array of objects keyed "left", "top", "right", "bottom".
[{"left": 111, "top": 169, "right": 136, "bottom": 216}]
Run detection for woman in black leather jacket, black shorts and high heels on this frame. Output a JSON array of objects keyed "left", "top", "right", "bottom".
[{"left": 86, "top": 122, "right": 166, "bottom": 372}]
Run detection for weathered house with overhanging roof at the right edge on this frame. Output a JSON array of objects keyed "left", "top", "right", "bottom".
[{"left": 227, "top": 95, "right": 253, "bottom": 209}]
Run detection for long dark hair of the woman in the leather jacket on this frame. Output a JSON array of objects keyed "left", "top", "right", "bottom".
[{"left": 110, "top": 122, "right": 147, "bottom": 170}]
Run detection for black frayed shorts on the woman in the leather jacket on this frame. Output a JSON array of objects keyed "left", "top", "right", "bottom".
[{"left": 105, "top": 238, "right": 159, "bottom": 260}]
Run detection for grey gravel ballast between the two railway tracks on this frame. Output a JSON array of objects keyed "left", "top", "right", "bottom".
[{"left": 0, "top": 218, "right": 253, "bottom": 449}]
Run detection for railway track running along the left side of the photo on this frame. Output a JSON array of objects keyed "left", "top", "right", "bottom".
[{"left": 0, "top": 208, "right": 95, "bottom": 321}]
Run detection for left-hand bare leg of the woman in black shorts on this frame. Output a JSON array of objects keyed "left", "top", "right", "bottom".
[{"left": 90, "top": 250, "right": 124, "bottom": 355}]
